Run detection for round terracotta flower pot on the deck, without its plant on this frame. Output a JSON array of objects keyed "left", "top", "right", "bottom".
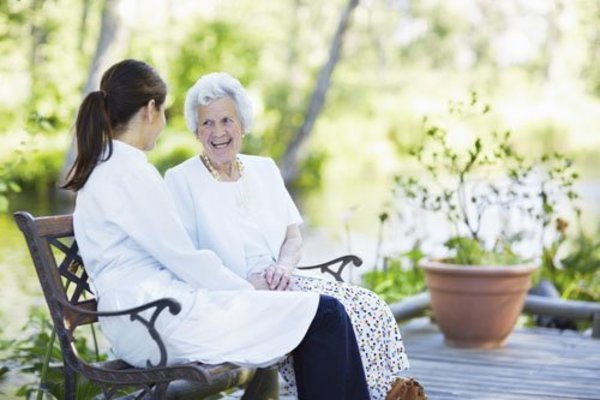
[{"left": 419, "top": 260, "right": 537, "bottom": 348}]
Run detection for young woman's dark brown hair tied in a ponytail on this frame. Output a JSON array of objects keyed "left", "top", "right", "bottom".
[{"left": 62, "top": 60, "right": 167, "bottom": 191}]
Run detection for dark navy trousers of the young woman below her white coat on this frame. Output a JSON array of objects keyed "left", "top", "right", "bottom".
[{"left": 292, "top": 295, "right": 370, "bottom": 400}]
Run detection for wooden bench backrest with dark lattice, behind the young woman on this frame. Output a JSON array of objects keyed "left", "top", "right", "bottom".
[{"left": 14, "top": 212, "right": 96, "bottom": 365}]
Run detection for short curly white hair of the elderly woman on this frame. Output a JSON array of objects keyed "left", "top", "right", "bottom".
[{"left": 184, "top": 72, "right": 252, "bottom": 134}]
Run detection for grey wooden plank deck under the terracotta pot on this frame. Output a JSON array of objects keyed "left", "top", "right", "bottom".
[{"left": 400, "top": 318, "right": 600, "bottom": 400}]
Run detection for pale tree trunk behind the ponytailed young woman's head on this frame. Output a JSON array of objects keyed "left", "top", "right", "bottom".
[{"left": 60, "top": 0, "right": 129, "bottom": 186}]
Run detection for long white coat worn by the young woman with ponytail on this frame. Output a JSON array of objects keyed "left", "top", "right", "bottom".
[{"left": 73, "top": 140, "right": 318, "bottom": 366}]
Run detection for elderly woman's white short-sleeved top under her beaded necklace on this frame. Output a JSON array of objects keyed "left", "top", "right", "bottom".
[{"left": 165, "top": 154, "right": 302, "bottom": 278}]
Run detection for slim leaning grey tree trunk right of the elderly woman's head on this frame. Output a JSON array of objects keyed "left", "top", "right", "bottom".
[{"left": 281, "top": 0, "right": 358, "bottom": 183}]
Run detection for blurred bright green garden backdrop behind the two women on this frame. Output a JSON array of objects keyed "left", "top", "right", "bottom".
[{"left": 0, "top": 0, "right": 600, "bottom": 394}]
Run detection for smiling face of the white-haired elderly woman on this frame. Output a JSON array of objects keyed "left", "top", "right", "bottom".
[{"left": 196, "top": 97, "right": 242, "bottom": 165}]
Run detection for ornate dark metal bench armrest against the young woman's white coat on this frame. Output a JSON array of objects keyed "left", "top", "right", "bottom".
[{"left": 56, "top": 297, "right": 181, "bottom": 367}]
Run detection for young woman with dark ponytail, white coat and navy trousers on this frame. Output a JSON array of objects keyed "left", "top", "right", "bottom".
[{"left": 64, "top": 60, "right": 369, "bottom": 400}]
